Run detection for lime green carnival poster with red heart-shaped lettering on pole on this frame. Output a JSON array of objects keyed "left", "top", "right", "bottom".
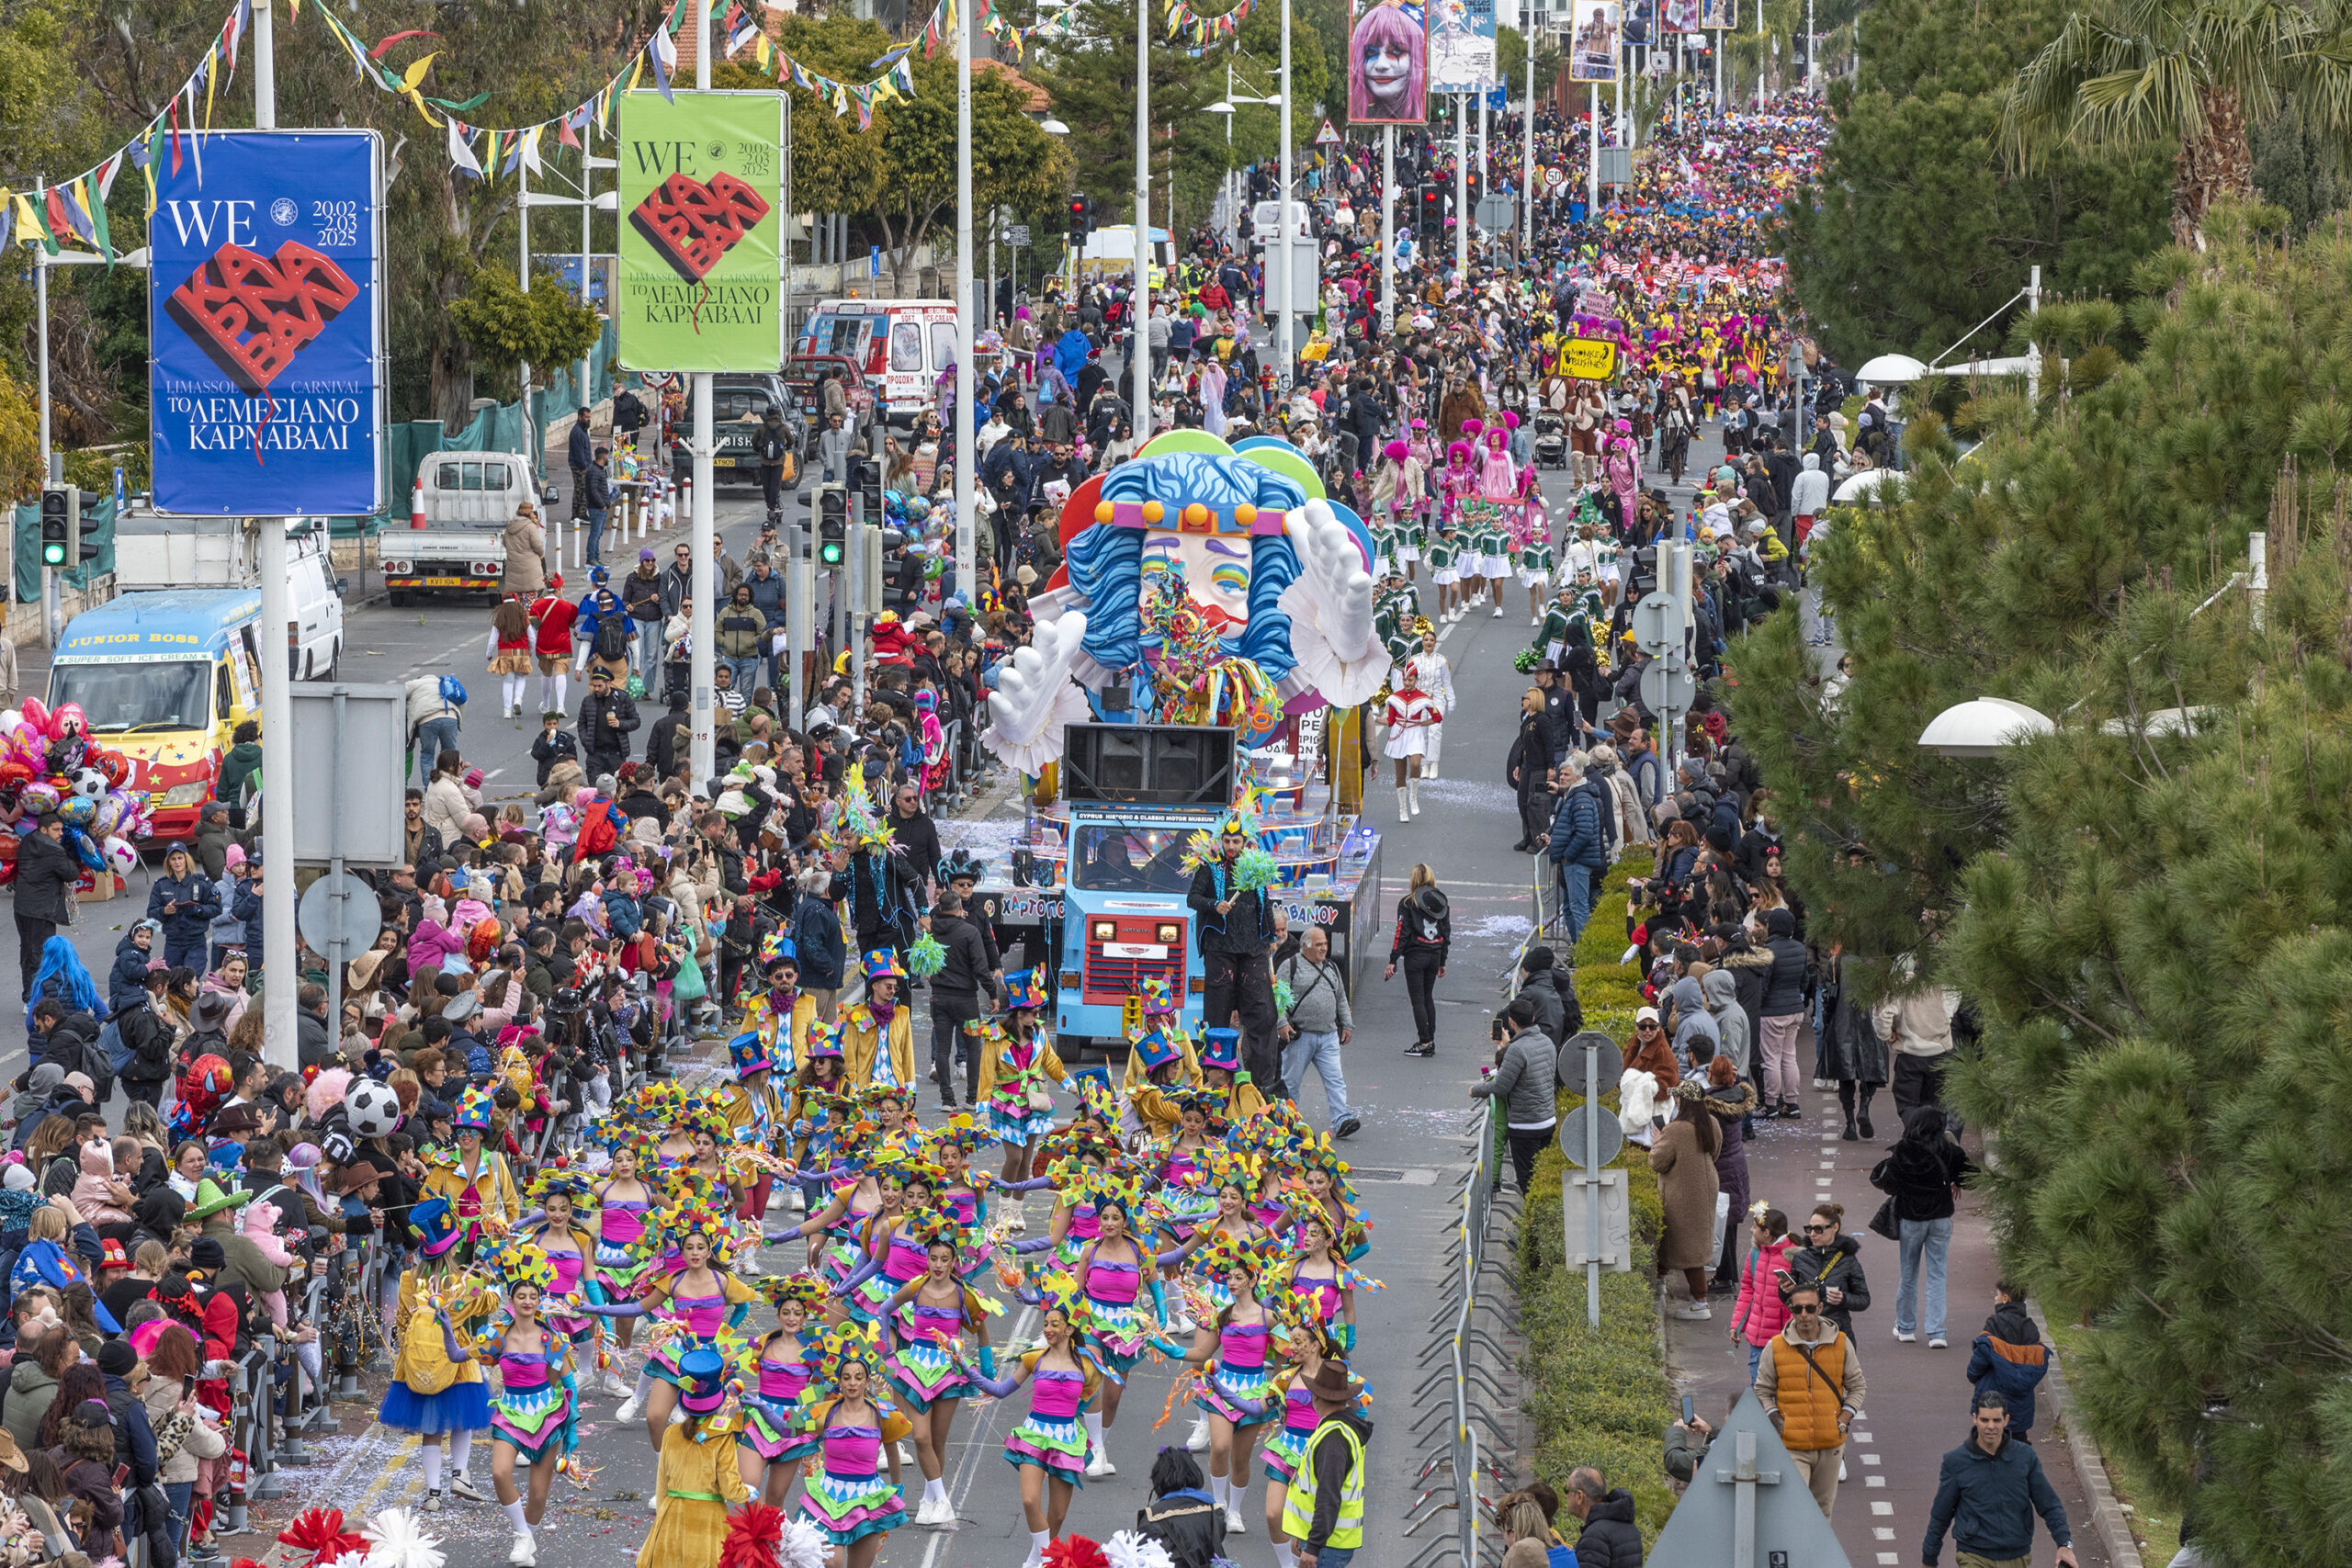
[{"left": 614, "top": 92, "right": 783, "bottom": 371}]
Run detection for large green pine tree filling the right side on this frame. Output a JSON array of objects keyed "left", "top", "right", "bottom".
[{"left": 1724, "top": 205, "right": 2352, "bottom": 1568}]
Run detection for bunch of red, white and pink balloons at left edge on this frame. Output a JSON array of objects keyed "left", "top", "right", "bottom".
[{"left": 0, "top": 698, "right": 155, "bottom": 886}]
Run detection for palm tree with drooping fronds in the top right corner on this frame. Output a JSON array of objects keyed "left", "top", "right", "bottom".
[{"left": 2002, "top": 0, "right": 2352, "bottom": 249}]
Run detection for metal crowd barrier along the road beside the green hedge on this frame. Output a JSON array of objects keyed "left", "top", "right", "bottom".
[{"left": 1404, "top": 1100, "right": 1517, "bottom": 1568}]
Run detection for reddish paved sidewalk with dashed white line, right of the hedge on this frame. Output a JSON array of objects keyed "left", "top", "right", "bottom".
[{"left": 1665, "top": 1081, "right": 2108, "bottom": 1568}]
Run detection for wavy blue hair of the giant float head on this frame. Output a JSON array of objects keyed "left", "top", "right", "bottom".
[{"left": 1066, "top": 451, "right": 1307, "bottom": 722}]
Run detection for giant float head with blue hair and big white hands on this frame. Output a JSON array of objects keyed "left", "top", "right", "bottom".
[{"left": 983, "top": 430, "right": 1387, "bottom": 771}]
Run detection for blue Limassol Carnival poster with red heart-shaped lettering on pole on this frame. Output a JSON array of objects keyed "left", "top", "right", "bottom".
[{"left": 148, "top": 131, "right": 386, "bottom": 517}]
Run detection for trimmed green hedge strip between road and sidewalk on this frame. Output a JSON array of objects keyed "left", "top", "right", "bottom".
[{"left": 1515, "top": 863, "right": 1677, "bottom": 1542}]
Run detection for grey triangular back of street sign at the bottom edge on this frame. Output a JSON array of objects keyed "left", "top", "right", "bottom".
[{"left": 1649, "top": 1389, "right": 1853, "bottom": 1568}]
